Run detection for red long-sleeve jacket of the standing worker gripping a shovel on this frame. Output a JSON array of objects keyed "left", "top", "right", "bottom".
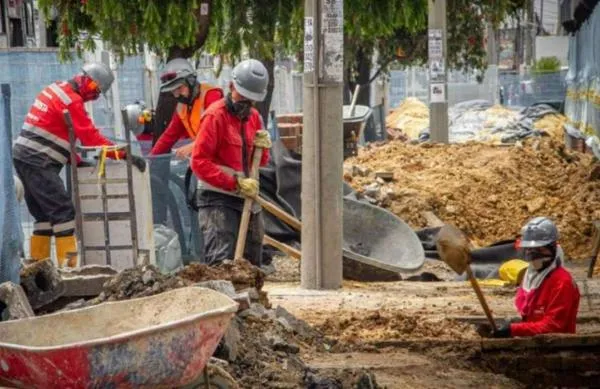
[{"left": 190, "top": 99, "right": 269, "bottom": 191}]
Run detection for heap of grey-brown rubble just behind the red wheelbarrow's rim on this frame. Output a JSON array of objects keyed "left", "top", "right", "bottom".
[{"left": 89, "top": 265, "right": 192, "bottom": 305}]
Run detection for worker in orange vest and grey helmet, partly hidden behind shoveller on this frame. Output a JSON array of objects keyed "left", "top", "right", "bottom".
[{"left": 150, "top": 58, "right": 223, "bottom": 159}]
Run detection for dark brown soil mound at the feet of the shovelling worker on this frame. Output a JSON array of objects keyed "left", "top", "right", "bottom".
[{"left": 177, "top": 259, "right": 265, "bottom": 291}]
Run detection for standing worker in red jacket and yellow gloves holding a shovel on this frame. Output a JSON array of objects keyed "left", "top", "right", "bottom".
[{"left": 191, "top": 59, "right": 271, "bottom": 266}]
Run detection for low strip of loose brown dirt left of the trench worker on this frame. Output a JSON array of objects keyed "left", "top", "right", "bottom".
[{"left": 315, "top": 310, "right": 479, "bottom": 344}]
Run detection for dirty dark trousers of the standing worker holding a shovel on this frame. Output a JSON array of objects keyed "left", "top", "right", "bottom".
[{"left": 198, "top": 205, "right": 265, "bottom": 267}]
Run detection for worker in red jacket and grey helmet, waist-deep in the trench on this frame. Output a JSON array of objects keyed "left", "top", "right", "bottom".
[{"left": 493, "top": 217, "right": 580, "bottom": 338}]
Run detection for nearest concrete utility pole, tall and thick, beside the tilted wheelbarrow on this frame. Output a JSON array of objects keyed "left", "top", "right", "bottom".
[{"left": 301, "top": 0, "right": 344, "bottom": 289}]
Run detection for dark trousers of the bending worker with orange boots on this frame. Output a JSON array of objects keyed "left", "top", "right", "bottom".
[{"left": 13, "top": 159, "right": 75, "bottom": 236}]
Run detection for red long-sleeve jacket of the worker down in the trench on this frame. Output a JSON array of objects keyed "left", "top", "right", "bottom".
[{"left": 510, "top": 266, "right": 580, "bottom": 336}]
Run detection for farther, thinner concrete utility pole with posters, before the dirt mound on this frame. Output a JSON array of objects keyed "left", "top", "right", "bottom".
[{"left": 429, "top": 0, "right": 449, "bottom": 143}]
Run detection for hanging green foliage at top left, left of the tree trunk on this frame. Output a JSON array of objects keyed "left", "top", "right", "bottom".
[{"left": 38, "top": 0, "right": 200, "bottom": 60}]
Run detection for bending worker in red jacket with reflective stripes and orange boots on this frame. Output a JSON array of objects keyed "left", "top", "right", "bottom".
[{"left": 13, "top": 63, "right": 145, "bottom": 267}]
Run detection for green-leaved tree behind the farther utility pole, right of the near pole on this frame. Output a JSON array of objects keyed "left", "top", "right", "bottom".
[{"left": 344, "top": 0, "right": 525, "bottom": 104}]
